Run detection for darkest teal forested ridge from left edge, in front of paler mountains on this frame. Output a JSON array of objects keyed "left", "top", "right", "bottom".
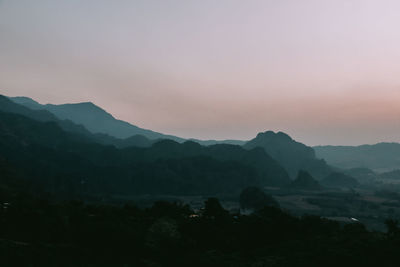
[{"left": 0, "top": 112, "right": 290, "bottom": 196}]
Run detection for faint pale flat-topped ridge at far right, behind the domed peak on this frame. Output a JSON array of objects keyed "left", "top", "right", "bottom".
[{"left": 314, "top": 143, "right": 400, "bottom": 172}]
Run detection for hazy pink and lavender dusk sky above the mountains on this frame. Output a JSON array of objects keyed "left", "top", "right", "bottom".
[{"left": 0, "top": 0, "right": 400, "bottom": 145}]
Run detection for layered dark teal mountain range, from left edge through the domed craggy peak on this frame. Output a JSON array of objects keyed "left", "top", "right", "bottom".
[{"left": 4, "top": 96, "right": 382, "bottom": 197}]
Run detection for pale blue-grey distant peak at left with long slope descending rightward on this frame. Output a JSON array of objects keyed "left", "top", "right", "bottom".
[{"left": 10, "top": 97, "right": 184, "bottom": 142}]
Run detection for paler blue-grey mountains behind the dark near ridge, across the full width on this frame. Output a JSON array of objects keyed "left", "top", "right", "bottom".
[{"left": 12, "top": 94, "right": 400, "bottom": 179}]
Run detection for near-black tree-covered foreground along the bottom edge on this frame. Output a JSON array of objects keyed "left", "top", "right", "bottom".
[{"left": 0, "top": 195, "right": 400, "bottom": 267}]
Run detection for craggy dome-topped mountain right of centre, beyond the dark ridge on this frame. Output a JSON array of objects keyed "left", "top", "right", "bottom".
[{"left": 244, "top": 131, "right": 331, "bottom": 179}]
